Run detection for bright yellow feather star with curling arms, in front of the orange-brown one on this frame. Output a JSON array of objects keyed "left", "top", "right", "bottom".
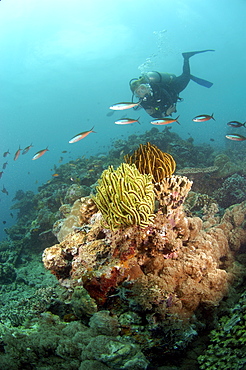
[{"left": 93, "top": 163, "right": 155, "bottom": 230}]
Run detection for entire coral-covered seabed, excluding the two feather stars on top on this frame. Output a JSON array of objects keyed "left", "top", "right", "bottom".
[{"left": 0, "top": 126, "right": 246, "bottom": 370}]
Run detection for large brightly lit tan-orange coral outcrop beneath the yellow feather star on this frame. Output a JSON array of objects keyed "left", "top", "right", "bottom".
[{"left": 43, "top": 171, "right": 245, "bottom": 358}]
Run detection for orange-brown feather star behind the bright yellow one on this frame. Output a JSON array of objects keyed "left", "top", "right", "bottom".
[{"left": 124, "top": 143, "right": 176, "bottom": 182}]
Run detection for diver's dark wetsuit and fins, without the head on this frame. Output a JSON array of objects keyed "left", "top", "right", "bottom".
[{"left": 140, "top": 50, "right": 212, "bottom": 118}]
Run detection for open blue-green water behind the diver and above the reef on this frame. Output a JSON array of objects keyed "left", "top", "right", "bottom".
[{"left": 0, "top": 0, "right": 246, "bottom": 239}]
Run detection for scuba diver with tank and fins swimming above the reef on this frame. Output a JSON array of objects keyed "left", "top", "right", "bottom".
[{"left": 129, "top": 50, "right": 214, "bottom": 118}]
